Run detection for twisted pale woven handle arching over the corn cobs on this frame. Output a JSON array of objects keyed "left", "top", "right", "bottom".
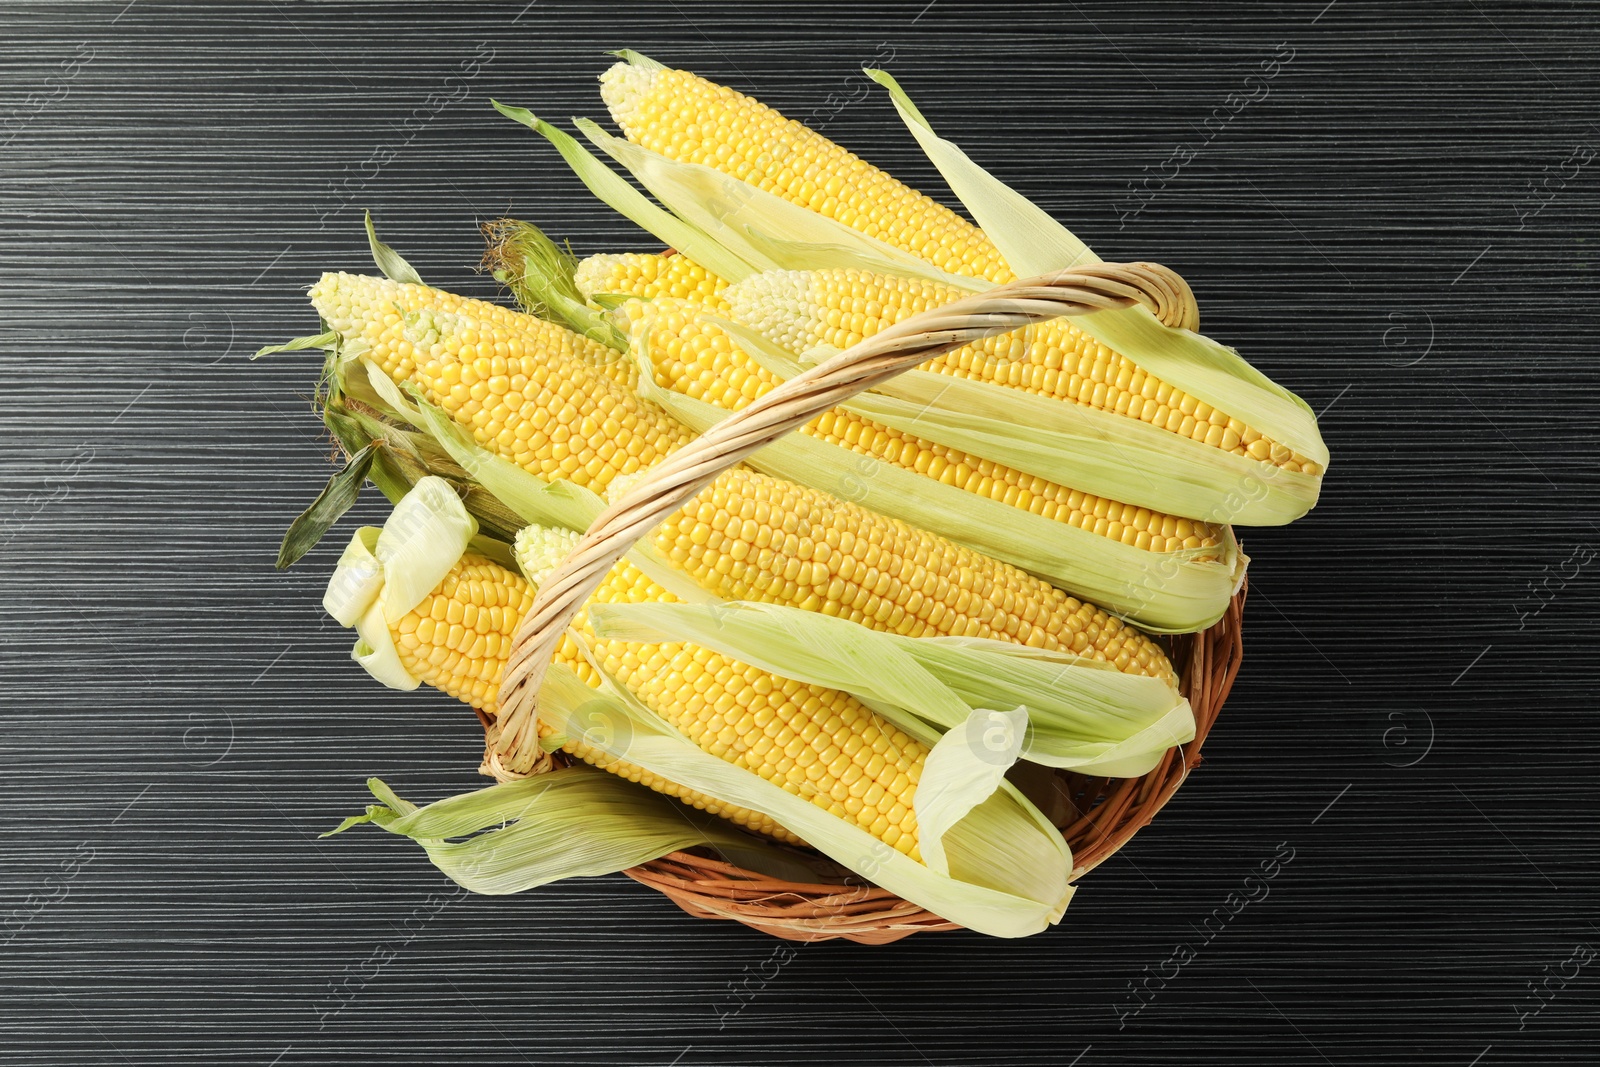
[{"left": 485, "top": 262, "right": 1200, "bottom": 781}]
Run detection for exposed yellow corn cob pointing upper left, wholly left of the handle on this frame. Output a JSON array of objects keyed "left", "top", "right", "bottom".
[{"left": 310, "top": 274, "right": 693, "bottom": 493}]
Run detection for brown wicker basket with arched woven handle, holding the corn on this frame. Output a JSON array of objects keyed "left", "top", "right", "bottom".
[{"left": 480, "top": 264, "right": 1245, "bottom": 944}]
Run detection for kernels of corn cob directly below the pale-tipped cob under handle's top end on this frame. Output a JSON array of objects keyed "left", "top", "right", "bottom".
[{"left": 621, "top": 295, "right": 1222, "bottom": 552}]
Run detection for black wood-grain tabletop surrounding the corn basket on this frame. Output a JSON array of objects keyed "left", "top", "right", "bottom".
[{"left": 0, "top": 0, "right": 1600, "bottom": 1067}]
